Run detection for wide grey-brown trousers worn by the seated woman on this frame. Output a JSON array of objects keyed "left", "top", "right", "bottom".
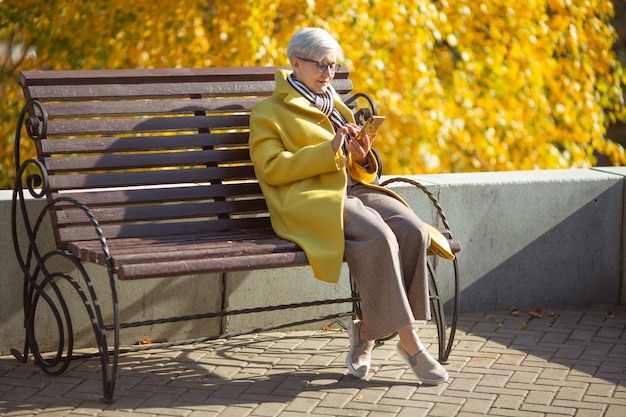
[{"left": 343, "top": 184, "right": 430, "bottom": 339}]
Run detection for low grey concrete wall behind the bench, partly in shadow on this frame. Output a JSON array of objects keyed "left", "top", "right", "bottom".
[{"left": 0, "top": 167, "right": 626, "bottom": 354}]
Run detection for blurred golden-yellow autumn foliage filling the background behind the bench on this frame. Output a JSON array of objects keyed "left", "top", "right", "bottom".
[{"left": 0, "top": 0, "right": 626, "bottom": 188}]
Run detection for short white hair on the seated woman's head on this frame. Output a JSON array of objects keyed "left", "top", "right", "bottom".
[{"left": 287, "top": 28, "right": 342, "bottom": 61}]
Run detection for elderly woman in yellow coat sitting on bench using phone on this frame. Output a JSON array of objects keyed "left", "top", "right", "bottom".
[{"left": 250, "top": 28, "right": 448, "bottom": 384}]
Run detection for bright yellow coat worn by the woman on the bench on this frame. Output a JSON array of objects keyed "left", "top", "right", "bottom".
[{"left": 250, "top": 70, "right": 377, "bottom": 283}]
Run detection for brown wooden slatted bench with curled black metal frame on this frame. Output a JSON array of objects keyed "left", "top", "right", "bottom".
[{"left": 12, "top": 67, "right": 460, "bottom": 401}]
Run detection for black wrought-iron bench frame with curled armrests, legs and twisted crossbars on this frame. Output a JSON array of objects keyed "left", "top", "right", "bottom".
[{"left": 11, "top": 68, "right": 460, "bottom": 402}]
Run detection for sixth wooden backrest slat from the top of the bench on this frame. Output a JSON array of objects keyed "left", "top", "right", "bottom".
[{"left": 44, "top": 149, "right": 250, "bottom": 173}]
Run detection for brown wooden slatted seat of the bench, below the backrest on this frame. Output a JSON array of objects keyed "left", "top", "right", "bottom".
[{"left": 68, "top": 224, "right": 460, "bottom": 280}]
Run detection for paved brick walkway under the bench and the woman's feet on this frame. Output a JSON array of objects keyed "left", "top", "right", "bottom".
[{"left": 0, "top": 306, "right": 626, "bottom": 417}]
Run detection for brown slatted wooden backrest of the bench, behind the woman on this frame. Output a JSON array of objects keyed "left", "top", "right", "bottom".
[{"left": 20, "top": 67, "right": 352, "bottom": 248}]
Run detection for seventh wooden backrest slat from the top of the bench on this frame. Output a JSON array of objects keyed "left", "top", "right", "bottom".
[{"left": 49, "top": 166, "right": 256, "bottom": 192}]
